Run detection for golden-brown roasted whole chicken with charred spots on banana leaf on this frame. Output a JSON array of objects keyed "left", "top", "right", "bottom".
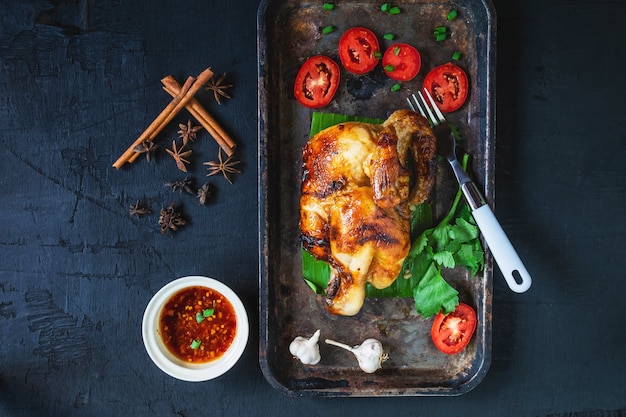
[{"left": 300, "top": 110, "right": 437, "bottom": 316}]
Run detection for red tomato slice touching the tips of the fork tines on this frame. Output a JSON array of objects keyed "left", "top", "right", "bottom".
[{"left": 424, "top": 63, "right": 469, "bottom": 113}]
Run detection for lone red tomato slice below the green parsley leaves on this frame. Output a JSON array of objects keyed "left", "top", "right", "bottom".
[{"left": 430, "top": 303, "right": 476, "bottom": 355}]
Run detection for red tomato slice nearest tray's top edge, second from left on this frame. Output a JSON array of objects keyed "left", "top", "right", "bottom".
[{"left": 339, "top": 26, "right": 380, "bottom": 74}]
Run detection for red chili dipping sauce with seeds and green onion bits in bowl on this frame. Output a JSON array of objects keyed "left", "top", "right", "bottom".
[{"left": 159, "top": 287, "right": 237, "bottom": 363}]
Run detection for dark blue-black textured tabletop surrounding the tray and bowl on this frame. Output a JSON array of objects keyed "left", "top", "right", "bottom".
[{"left": 0, "top": 0, "right": 626, "bottom": 417}]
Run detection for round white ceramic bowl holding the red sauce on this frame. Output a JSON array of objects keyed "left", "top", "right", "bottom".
[{"left": 142, "top": 276, "right": 250, "bottom": 382}]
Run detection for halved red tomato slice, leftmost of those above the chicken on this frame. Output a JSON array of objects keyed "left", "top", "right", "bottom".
[{"left": 293, "top": 55, "right": 339, "bottom": 109}]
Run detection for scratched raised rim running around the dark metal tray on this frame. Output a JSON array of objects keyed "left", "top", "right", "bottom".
[{"left": 257, "top": 0, "right": 496, "bottom": 397}]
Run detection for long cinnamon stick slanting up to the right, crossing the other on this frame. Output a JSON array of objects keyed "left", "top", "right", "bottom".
[{"left": 113, "top": 68, "right": 213, "bottom": 169}]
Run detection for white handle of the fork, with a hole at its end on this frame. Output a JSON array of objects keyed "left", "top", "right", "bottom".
[{"left": 472, "top": 204, "right": 532, "bottom": 293}]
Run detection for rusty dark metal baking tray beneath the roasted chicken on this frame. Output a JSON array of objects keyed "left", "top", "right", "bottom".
[{"left": 258, "top": 0, "right": 496, "bottom": 396}]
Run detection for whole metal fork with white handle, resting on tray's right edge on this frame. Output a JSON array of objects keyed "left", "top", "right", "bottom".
[{"left": 407, "top": 90, "right": 532, "bottom": 293}]
